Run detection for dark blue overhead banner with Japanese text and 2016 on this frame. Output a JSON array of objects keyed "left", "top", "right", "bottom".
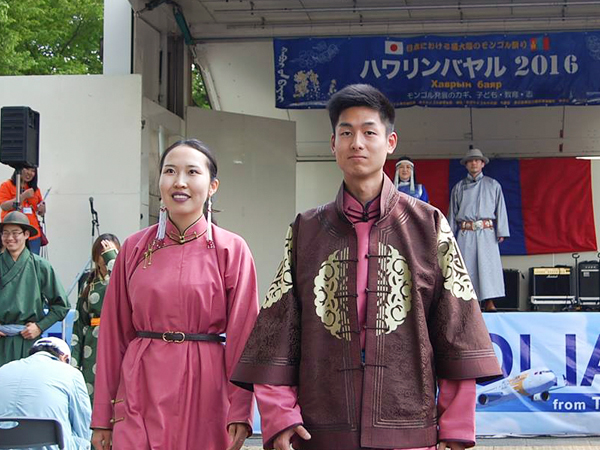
[{"left": 274, "top": 32, "right": 600, "bottom": 109}]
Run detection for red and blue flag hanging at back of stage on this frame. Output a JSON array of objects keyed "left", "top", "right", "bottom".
[{"left": 384, "top": 158, "right": 597, "bottom": 255}]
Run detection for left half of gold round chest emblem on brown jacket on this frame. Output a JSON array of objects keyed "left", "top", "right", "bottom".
[{"left": 313, "top": 247, "right": 350, "bottom": 341}]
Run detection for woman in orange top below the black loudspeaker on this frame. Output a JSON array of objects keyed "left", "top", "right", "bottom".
[{"left": 0, "top": 167, "right": 46, "bottom": 255}]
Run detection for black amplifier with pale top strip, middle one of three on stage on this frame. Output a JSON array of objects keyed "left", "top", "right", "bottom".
[{"left": 529, "top": 266, "right": 575, "bottom": 305}]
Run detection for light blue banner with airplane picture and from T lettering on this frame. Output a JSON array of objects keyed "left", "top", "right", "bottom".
[{"left": 476, "top": 312, "right": 600, "bottom": 436}]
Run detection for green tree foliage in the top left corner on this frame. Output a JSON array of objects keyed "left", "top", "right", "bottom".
[{"left": 0, "top": 0, "right": 104, "bottom": 75}]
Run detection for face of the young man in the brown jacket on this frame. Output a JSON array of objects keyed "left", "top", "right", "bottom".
[{"left": 331, "top": 106, "right": 398, "bottom": 181}]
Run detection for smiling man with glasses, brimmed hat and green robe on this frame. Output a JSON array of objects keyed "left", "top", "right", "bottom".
[{"left": 0, "top": 211, "right": 69, "bottom": 366}]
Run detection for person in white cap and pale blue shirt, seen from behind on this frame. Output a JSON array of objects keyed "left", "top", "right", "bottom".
[{"left": 0, "top": 337, "right": 92, "bottom": 450}]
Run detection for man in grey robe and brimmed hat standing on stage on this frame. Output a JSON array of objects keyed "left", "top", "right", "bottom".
[{"left": 448, "top": 148, "right": 510, "bottom": 312}]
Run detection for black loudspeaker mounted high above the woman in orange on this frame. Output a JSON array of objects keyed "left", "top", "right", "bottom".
[{"left": 0, "top": 106, "right": 40, "bottom": 168}]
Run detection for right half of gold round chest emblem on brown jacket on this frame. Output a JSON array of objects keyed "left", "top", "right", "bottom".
[{"left": 376, "top": 242, "right": 412, "bottom": 336}]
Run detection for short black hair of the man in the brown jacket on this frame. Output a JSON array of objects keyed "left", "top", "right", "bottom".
[{"left": 327, "top": 84, "right": 396, "bottom": 134}]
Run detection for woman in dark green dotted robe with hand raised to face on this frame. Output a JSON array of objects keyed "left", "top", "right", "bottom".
[{"left": 71, "top": 233, "right": 121, "bottom": 404}]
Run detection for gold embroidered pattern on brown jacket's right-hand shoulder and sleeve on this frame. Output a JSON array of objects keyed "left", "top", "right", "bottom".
[{"left": 437, "top": 217, "right": 477, "bottom": 301}]
